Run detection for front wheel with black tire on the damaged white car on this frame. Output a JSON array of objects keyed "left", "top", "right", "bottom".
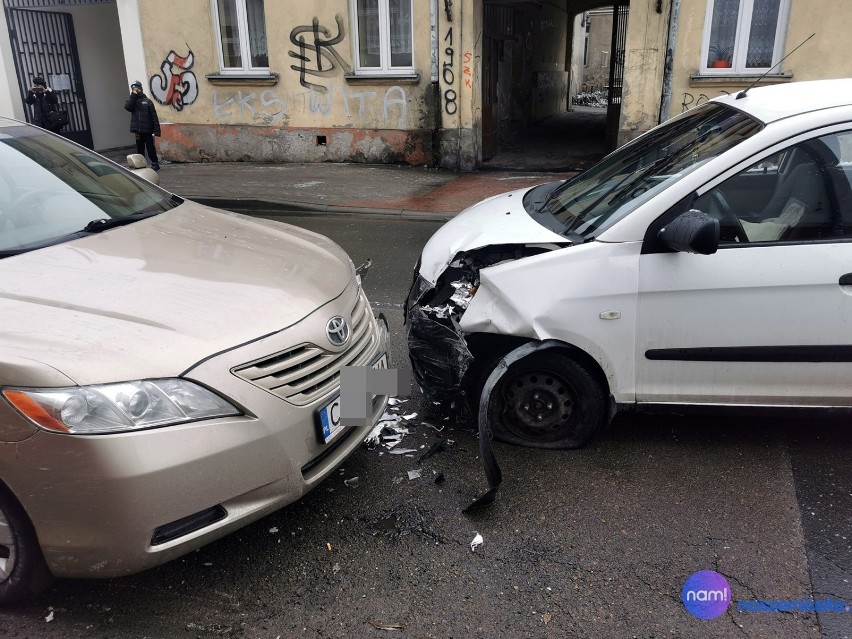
[{"left": 478, "top": 350, "right": 607, "bottom": 449}]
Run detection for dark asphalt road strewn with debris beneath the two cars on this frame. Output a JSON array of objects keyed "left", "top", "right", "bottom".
[{"left": 0, "top": 215, "right": 852, "bottom": 639}]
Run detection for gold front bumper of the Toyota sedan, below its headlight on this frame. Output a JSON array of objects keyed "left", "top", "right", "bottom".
[{"left": 0, "top": 286, "right": 388, "bottom": 577}]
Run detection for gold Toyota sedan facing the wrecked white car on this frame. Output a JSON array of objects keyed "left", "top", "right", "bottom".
[{"left": 0, "top": 118, "right": 388, "bottom": 604}]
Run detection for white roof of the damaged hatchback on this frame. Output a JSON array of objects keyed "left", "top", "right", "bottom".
[{"left": 713, "top": 78, "right": 852, "bottom": 123}]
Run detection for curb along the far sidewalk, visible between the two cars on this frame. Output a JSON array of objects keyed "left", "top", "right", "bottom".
[{"left": 187, "top": 195, "right": 458, "bottom": 221}]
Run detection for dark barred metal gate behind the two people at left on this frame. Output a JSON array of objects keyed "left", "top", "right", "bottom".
[{"left": 6, "top": 3, "right": 93, "bottom": 149}]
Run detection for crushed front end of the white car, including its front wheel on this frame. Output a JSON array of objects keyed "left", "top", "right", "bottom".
[{"left": 405, "top": 182, "right": 606, "bottom": 448}]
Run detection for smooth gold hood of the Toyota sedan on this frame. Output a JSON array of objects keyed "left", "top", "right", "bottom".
[{"left": 0, "top": 202, "right": 354, "bottom": 385}]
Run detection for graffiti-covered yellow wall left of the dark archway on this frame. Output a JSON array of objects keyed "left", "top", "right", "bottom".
[{"left": 140, "top": 0, "right": 456, "bottom": 164}]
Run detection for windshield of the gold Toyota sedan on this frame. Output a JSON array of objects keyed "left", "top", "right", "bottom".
[{"left": 0, "top": 124, "right": 181, "bottom": 257}]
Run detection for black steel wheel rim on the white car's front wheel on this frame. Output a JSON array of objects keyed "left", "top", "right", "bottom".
[{"left": 501, "top": 371, "right": 580, "bottom": 440}]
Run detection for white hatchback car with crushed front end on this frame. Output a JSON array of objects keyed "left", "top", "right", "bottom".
[{"left": 406, "top": 80, "right": 852, "bottom": 448}]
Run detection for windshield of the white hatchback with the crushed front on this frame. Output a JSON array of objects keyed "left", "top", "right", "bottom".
[{"left": 536, "top": 104, "right": 761, "bottom": 241}]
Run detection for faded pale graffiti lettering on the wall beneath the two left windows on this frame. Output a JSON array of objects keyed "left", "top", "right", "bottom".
[{"left": 213, "top": 86, "right": 408, "bottom": 129}]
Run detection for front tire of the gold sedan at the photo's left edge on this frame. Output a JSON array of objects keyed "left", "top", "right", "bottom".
[{"left": 0, "top": 485, "right": 54, "bottom": 606}]
